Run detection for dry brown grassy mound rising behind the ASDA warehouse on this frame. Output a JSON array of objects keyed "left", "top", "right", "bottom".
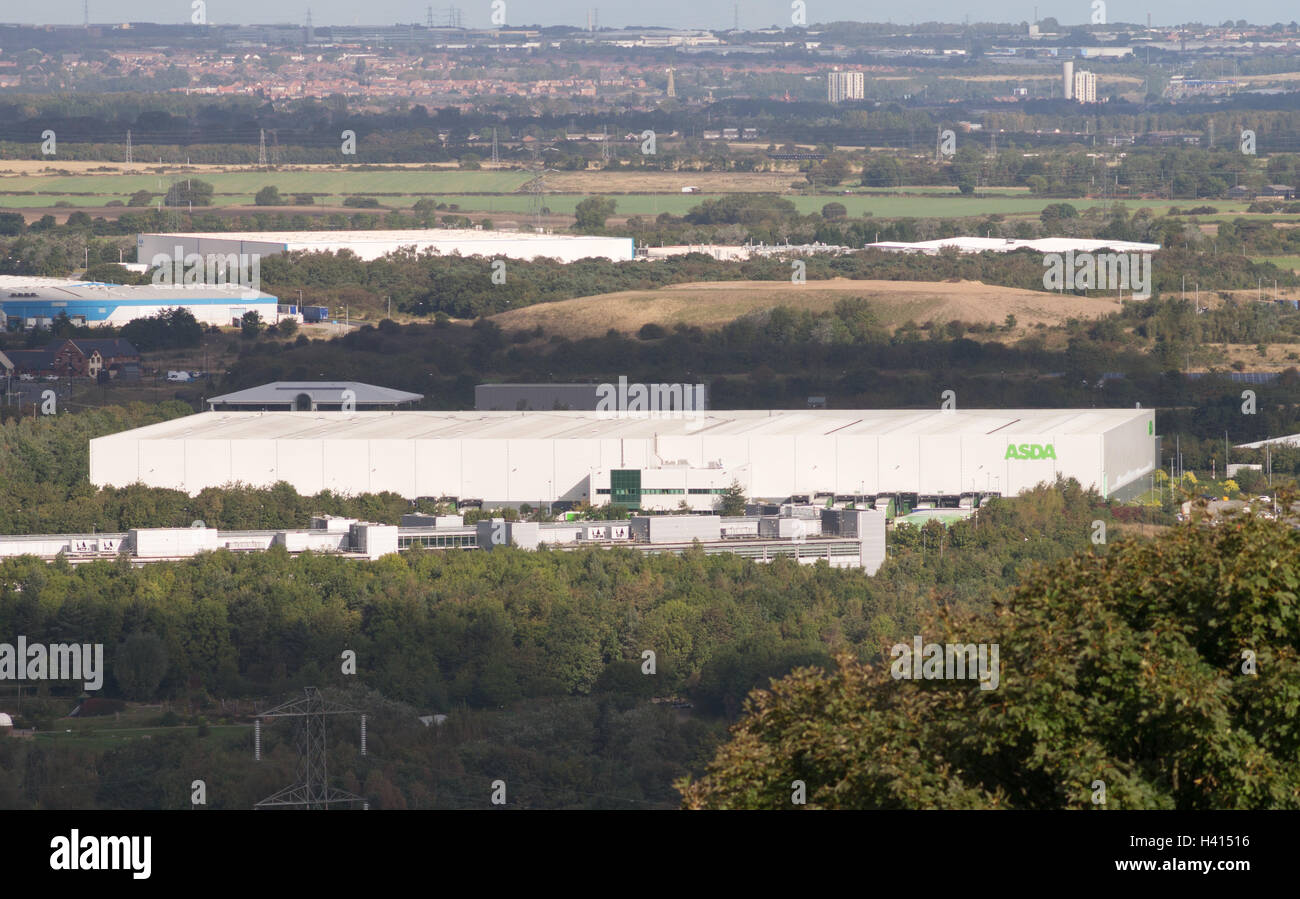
[{"left": 494, "top": 278, "right": 1119, "bottom": 338}]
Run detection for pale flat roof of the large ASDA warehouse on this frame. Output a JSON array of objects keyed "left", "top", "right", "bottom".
[{"left": 101, "top": 399, "right": 1149, "bottom": 440}]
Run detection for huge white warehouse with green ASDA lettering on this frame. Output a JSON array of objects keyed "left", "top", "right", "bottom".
[{"left": 90, "top": 409, "right": 1158, "bottom": 511}]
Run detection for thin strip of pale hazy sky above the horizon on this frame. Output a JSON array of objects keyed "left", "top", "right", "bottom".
[{"left": 17, "top": 0, "right": 1300, "bottom": 27}]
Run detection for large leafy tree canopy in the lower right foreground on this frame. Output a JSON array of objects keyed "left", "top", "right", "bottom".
[{"left": 679, "top": 517, "right": 1300, "bottom": 809}]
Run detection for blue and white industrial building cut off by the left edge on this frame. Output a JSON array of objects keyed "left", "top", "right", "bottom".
[{"left": 0, "top": 275, "right": 280, "bottom": 327}]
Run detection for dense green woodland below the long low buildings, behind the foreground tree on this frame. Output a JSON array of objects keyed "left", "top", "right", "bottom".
[{"left": 0, "top": 483, "right": 1110, "bottom": 808}]
